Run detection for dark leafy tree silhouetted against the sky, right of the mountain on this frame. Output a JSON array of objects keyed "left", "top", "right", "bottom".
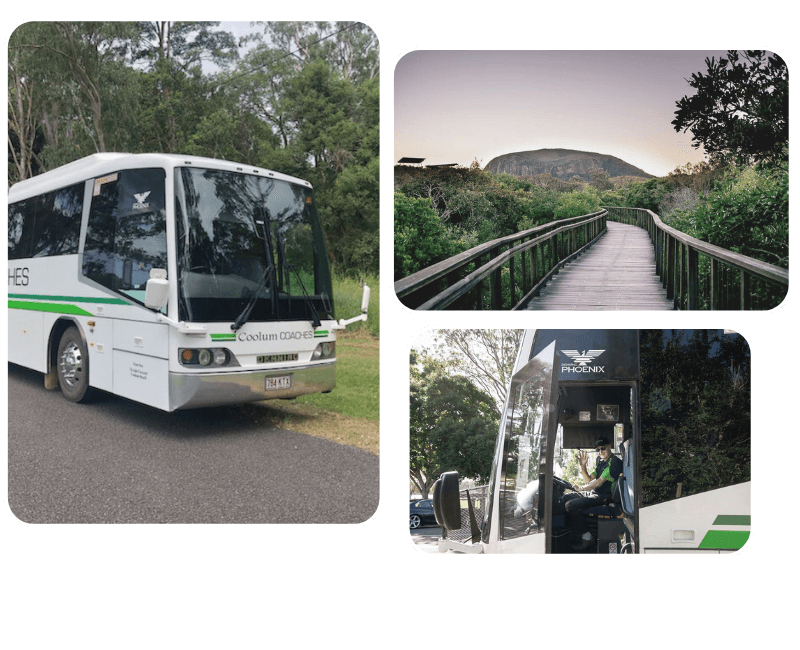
[{"left": 672, "top": 50, "right": 789, "bottom": 164}]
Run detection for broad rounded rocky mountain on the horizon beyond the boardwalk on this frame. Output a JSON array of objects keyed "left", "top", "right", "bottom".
[{"left": 484, "top": 149, "right": 655, "bottom": 181}]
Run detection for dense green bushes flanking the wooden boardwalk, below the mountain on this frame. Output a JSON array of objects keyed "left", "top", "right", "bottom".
[{"left": 394, "top": 158, "right": 789, "bottom": 278}]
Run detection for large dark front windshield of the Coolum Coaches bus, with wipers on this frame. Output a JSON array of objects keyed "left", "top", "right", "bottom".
[{"left": 175, "top": 167, "right": 333, "bottom": 323}]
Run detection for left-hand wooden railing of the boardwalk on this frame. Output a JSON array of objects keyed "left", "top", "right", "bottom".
[{"left": 394, "top": 209, "right": 607, "bottom": 310}]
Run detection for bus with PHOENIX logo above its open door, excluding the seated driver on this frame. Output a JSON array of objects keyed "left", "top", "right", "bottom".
[{"left": 433, "top": 329, "right": 754, "bottom": 555}]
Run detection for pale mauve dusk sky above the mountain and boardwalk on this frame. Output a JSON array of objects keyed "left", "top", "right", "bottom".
[{"left": 391, "top": 48, "right": 740, "bottom": 176}]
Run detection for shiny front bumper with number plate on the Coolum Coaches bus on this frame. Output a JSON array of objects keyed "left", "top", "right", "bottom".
[{"left": 169, "top": 359, "right": 336, "bottom": 411}]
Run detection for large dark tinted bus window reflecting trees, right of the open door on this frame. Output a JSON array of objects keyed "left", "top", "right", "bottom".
[{"left": 639, "top": 329, "right": 752, "bottom": 505}]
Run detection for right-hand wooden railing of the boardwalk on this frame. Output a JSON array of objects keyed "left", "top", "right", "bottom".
[{"left": 606, "top": 207, "right": 789, "bottom": 310}]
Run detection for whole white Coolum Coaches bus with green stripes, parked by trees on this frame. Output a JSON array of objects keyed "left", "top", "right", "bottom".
[{"left": 7, "top": 153, "right": 369, "bottom": 411}]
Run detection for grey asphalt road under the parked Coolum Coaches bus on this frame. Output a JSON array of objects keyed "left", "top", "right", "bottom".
[{"left": 6, "top": 364, "right": 380, "bottom": 525}]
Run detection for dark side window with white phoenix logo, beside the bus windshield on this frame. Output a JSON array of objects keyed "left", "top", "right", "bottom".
[{"left": 83, "top": 169, "right": 167, "bottom": 302}]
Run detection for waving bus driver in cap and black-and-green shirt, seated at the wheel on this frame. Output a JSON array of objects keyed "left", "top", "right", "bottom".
[{"left": 561, "top": 438, "right": 622, "bottom": 550}]
